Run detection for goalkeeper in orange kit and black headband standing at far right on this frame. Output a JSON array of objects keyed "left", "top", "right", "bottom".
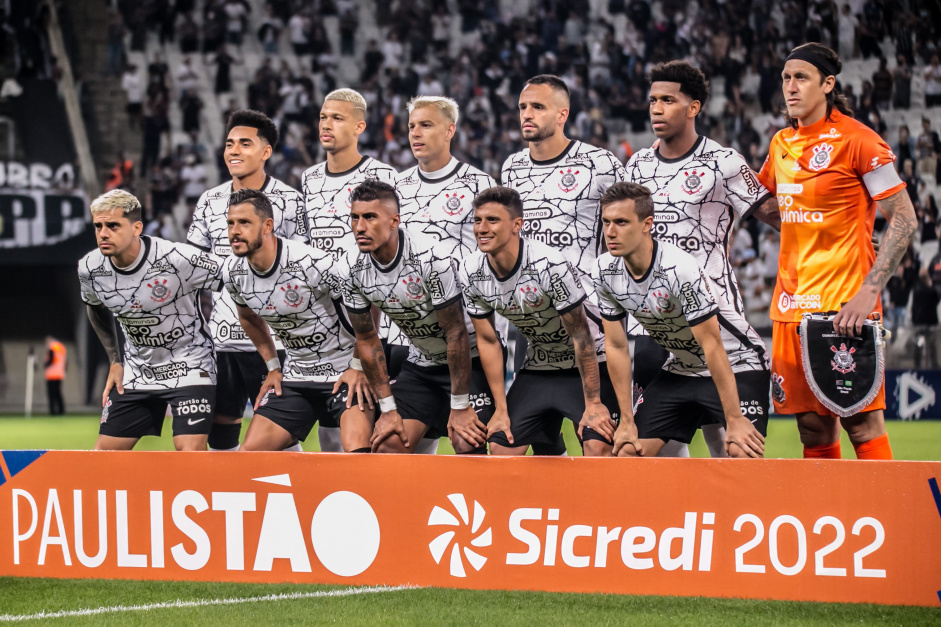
[{"left": 759, "top": 43, "right": 917, "bottom": 459}]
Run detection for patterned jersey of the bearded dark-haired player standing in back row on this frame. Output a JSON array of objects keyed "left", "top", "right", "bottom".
[{"left": 502, "top": 141, "right": 625, "bottom": 284}]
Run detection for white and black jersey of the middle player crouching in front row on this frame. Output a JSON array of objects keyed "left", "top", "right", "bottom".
[{"left": 343, "top": 229, "right": 477, "bottom": 366}]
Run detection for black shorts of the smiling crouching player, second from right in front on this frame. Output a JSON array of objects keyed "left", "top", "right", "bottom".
[{"left": 490, "top": 363, "right": 620, "bottom": 447}]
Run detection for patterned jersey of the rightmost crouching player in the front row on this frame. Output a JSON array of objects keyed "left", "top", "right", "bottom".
[{"left": 593, "top": 240, "right": 768, "bottom": 377}]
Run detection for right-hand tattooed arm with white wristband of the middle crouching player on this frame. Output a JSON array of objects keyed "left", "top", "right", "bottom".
[{"left": 437, "top": 298, "right": 487, "bottom": 453}]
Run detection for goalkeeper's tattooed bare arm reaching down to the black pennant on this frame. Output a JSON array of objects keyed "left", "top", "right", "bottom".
[{"left": 833, "top": 189, "right": 918, "bottom": 335}]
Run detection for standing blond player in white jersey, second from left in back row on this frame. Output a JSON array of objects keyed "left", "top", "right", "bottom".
[{"left": 297, "top": 89, "right": 396, "bottom": 259}]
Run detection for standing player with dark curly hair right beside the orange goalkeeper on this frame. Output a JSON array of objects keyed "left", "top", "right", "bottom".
[{"left": 625, "top": 61, "right": 781, "bottom": 457}]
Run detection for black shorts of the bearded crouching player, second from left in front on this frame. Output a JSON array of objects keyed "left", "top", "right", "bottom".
[{"left": 255, "top": 382, "right": 348, "bottom": 440}]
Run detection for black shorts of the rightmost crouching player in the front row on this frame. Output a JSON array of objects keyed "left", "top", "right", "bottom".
[{"left": 634, "top": 370, "right": 771, "bottom": 444}]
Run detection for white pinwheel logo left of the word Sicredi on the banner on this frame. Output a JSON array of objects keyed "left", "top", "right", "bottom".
[{"left": 428, "top": 494, "right": 493, "bottom": 577}]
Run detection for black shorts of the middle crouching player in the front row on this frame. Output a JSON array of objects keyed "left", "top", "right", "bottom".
[{"left": 392, "top": 357, "right": 494, "bottom": 438}]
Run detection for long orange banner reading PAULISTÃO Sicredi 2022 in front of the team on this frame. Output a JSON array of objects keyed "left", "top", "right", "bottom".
[{"left": 0, "top": 451, "right": 941, "bottom": 606}]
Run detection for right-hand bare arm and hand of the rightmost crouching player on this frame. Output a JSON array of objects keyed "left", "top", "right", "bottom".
[{"left": 690, "top": 316, "right": 765, "bottom": 457}]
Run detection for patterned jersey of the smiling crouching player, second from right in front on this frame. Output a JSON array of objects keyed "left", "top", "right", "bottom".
[{"left": 460, "top": 238, "right": 586, "bottom": 370}]
